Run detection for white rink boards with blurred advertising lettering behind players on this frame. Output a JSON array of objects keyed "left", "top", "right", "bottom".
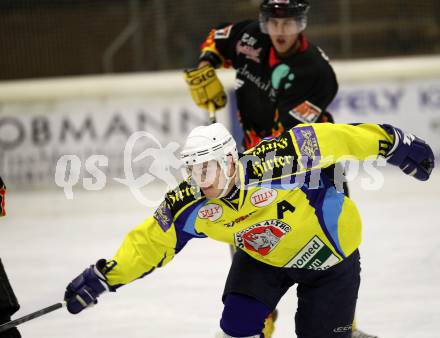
[{"left": 0, "top": 56, "right": 440, "bottom": 187}]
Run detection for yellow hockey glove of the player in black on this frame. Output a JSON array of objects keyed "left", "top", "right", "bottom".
[{"left": 185, "top": 65, "right": 226, "bottom": 111}]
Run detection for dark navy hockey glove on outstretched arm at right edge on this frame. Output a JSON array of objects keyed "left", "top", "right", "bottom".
[{"left": 382, "top": 124, "right": 434, "bottom": 181}]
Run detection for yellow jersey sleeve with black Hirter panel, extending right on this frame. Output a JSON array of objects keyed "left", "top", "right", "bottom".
[{"left": 244, "top": 123, "right": 394, "bottom": 184}]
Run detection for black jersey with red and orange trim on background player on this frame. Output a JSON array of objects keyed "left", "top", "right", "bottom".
[{"left": 200, "top": 21, "right": 338, "bottom": 148}]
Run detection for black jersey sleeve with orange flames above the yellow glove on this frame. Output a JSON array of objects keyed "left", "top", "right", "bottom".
[{"left": 199, "top": 21, "right": 251, "bottom": 68}]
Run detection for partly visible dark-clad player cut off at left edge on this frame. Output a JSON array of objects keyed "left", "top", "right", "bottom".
[{"left": 0, "top": 177, "right": 21, "bottom": 338}]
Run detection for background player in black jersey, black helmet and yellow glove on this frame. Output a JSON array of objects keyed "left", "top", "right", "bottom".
[{"left": 187, "top": 0, "right": 374, "bottom": 338}]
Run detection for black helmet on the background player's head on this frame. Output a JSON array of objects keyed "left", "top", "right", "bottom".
[{"left": 260, "top": 0, "right": 310, "bottom": 18}]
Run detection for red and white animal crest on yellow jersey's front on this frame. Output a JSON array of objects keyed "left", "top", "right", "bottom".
[{"left": 234, "top": 219, "right": 292, "bottom": 256}]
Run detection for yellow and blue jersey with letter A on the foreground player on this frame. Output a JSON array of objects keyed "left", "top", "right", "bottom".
[{"left": 106, "top": 123, "right": 393, "bottom": 286}]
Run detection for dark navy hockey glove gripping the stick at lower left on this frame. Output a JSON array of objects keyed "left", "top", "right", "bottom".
[{"left": 64, "top": 259, "right": 111, "bottom": 314}]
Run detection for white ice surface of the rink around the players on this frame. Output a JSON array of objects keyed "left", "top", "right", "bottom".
[{"left": 0, "top": 169, "right": 440, "bottom": 338}]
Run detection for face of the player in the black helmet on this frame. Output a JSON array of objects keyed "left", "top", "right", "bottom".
[{"left": 267, "top": 18, "right": 299, "bottom": 56}]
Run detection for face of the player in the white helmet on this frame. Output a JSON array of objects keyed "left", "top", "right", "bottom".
[{"left": 189, "top": 161, "right": 230, "bottom": 199}]
